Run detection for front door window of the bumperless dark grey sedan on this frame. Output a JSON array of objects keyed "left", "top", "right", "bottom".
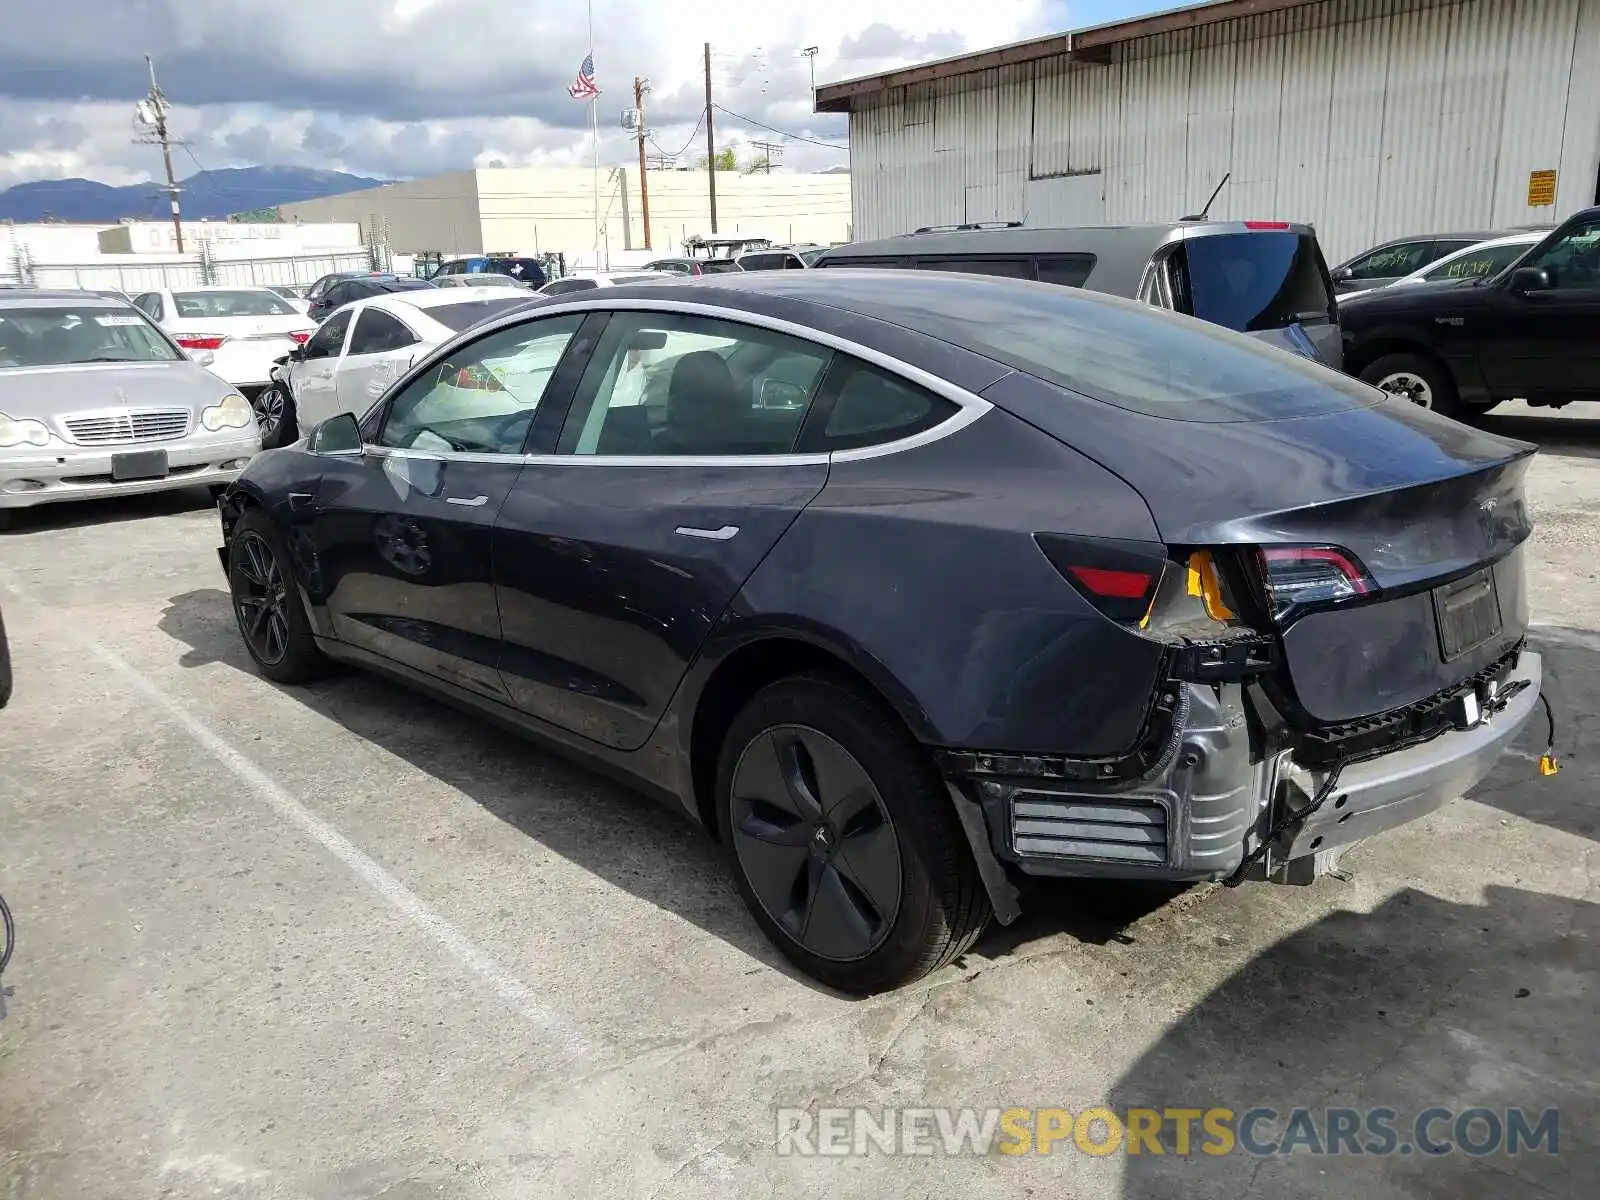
[{"left": 378, "top": 314, "right": 584, "bottom": 454}]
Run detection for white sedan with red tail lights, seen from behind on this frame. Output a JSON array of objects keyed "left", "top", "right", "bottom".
[{"left": 133, "top": 286, "right": 317, "bottom": 397}]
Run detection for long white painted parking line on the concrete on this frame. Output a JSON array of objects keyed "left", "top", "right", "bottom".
[{"left": 0, "top": 584, "right": 589, "bottom": 1059}]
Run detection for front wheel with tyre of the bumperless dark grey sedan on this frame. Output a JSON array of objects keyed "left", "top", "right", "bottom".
[{"left": 227, "top": 509, "right": 330, "bottom": 683}]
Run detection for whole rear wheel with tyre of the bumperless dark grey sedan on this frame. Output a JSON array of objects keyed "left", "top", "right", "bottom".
[{"left": 717, "top": 675, "right": 990, "bottom": 994}]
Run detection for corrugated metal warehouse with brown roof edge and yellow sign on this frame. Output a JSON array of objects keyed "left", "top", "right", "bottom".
[{"left": 816, "top": 0, "right": 1600, "bottom": 261}]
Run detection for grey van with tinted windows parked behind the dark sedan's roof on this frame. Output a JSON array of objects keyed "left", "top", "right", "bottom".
[{"left": 816, "top": 221, "right": 1342, "bottom": 368}]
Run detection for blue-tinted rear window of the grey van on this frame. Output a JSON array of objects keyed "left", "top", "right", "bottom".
[{"left": 1178, "top": 234, "right": 1333, "bottom": 333}]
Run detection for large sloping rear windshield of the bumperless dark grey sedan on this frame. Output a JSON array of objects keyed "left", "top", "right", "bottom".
[{"left": 874, "top": 274, "right": 1376, "bottom": 421}]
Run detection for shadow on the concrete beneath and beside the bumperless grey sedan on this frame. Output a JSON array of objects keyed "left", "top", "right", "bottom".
[{"left": 158, "top": 589, "right": 1181, "bottom": 994}]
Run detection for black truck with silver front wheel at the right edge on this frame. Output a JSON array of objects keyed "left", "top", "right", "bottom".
[{"left": 1339, "top": 208, "right": 1600, "bottom": 416}]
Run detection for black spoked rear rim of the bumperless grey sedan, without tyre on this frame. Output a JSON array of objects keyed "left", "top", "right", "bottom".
[{"left": 733, "top": 725, "right": 901, "bottom": 962}]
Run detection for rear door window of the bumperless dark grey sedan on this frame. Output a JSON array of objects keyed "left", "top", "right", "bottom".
[{"left": 557, "top": 312, "right": 832, "bottom": 456}]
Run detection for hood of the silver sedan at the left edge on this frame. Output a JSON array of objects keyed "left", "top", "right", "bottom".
[{"left": 0, "top": 360, "right": 234, "bottom": 419}]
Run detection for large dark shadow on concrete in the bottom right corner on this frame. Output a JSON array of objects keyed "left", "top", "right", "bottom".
[{"left": 1107, "top": 886, "right": 1600, "bottom": 1200}]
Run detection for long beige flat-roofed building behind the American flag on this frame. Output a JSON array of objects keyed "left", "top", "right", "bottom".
[{"left": 278, "top": 166, "right": 851, "bottom": 267}]
